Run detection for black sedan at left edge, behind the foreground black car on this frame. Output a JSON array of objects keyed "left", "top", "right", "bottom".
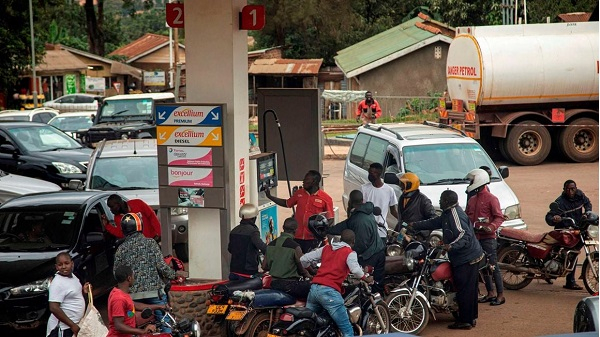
[{"left": 0, "top": 122, "right": 92, "bottom": 189}]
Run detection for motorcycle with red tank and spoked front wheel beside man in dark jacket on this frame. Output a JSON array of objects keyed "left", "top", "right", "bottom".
[{"left": 386, "top": 240, "right": 458, "bottom": 334}]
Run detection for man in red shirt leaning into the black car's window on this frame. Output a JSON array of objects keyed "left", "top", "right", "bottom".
[{"left": 102, "top": 194, "right": 160, "bottom": 241}]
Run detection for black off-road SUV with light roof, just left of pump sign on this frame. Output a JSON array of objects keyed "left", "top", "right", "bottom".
[{"left": 82, "top": 92, "right": 175, "bottom": 147}]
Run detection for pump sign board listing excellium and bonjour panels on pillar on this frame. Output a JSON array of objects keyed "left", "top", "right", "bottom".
[{"left": 154, "top": 102, "right": 226, "bottom": 209}]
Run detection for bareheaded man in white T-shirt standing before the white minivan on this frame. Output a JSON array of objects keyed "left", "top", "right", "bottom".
[{"left": 361, "top": 163, "right": 398, "bottom": 242}]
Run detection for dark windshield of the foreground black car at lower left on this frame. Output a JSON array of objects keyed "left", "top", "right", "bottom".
[{"left": 0, "top": 207, "right": 80, "bottom": 252}]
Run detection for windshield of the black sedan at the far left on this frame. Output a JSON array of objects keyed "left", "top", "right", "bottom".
[{"left": 8, "top": 125, "right": 82, "bottom": 152}]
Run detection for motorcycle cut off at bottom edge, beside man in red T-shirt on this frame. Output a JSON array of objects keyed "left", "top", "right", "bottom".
[{"left": 137, "top": 308, "right": 200, "bottom": 337}]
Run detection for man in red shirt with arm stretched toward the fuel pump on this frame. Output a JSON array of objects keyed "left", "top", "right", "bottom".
[{"left": 265, "top": 170, "right": 333, "bottom": 253}]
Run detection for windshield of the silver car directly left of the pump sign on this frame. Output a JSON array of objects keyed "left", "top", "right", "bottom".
[{"left": 89, "top": 156, "right": 158, "bottom": 191}]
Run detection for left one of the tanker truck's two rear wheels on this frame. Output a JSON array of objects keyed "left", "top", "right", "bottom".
[{"left": 505, "top": 121, "right": 552, "bottom": 165}]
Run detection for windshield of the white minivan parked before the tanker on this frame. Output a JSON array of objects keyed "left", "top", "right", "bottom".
[{"left": 402, "top": 144, "right": 501, "bottom": 185}]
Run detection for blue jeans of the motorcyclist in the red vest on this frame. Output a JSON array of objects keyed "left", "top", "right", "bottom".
[{"left": 306, "top": 284, "right": 354, "bottom": 337}]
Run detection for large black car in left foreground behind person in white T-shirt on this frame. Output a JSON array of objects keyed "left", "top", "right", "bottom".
[{"left": 0, "top": 191, "right": 116, "bottom": 331}]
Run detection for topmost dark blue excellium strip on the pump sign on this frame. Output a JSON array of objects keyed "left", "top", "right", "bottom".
[{"left": 156, "top": 105, "right": 223, "bottom": 126}]
